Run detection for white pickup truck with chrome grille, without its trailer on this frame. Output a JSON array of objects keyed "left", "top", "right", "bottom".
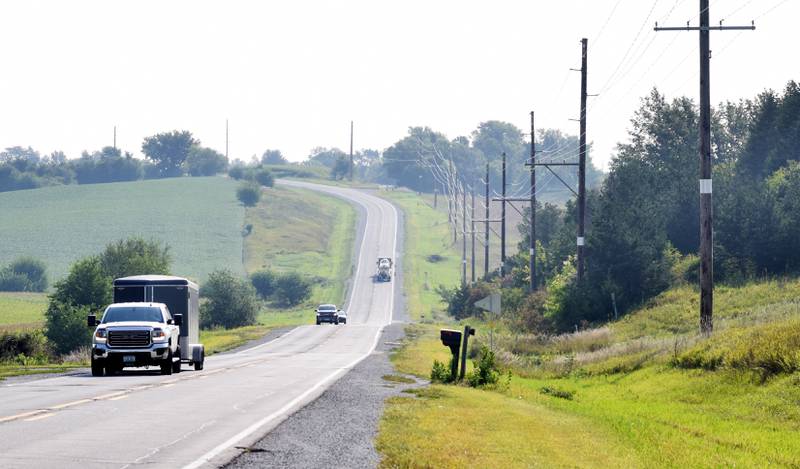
[{"left": 88, "top": 302, "right": 183, "bottom": 376}]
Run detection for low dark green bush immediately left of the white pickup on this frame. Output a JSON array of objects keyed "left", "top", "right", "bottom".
[{"left": 44, "top": 300, "right": 92, "bottom": 354}]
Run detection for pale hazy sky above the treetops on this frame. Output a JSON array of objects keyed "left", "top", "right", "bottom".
[{"left": 0, "top": 0, "right": 800, "bottom": 166}]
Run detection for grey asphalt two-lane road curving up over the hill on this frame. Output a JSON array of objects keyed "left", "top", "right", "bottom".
[{"left": 0, "top": 181, "right": 400, "bottom": 468}]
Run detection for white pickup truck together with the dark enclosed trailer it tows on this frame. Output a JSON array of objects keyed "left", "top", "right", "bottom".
[{"left": 88, "top": 275, "right": 205, "bottom": 376}]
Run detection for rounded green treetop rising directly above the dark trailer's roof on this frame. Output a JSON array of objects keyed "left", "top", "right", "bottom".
[{"left": 99, "top": 237, "right": 172, "bottom": 279}]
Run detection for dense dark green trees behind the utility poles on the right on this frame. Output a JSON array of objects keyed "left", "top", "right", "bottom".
[{"left": 442, "top": 82, "right": 800, "bottom": 331}]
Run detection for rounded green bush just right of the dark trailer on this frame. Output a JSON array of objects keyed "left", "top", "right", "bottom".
[{"left": 200, "top": 270, "right": 258, "bottom": 329}]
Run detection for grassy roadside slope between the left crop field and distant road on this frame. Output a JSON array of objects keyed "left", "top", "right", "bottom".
[{"left": 245, "top": 186, "right": 356, "bottom": 327}]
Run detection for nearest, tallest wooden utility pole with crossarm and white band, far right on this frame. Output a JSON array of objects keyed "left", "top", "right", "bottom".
[{"left": 654, "top": 0, "right": 756, "bottom": 335}]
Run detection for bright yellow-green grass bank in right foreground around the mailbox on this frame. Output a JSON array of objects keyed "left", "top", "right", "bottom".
[{"left": 377, "top": 189, "right": 800, "bottom": 468}]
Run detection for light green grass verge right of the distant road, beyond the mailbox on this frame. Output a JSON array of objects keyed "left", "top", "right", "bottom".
[{"left": 379, "top": 190, "right": 461, "bottom": 320}]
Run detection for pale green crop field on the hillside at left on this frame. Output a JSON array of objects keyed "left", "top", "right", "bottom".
[{"left": 0, "top": 177, "right": 244, "bottom": 281}]
